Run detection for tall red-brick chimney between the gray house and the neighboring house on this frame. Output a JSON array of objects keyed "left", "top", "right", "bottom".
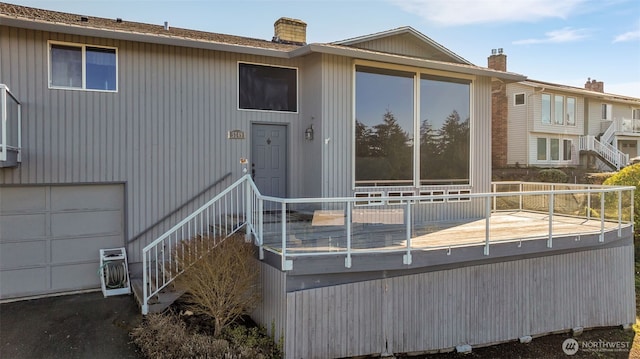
[{"left": 488, "top": 49, "right": 509, "bottom": 168}]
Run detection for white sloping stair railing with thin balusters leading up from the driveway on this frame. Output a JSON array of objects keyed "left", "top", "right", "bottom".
[{"left": 142, "top": 175, "right": 260, "bottom": 314}]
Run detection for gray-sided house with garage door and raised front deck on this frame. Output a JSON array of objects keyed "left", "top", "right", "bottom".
[{"left": 0, "top": 4, "right": 635, "bottom": 358}]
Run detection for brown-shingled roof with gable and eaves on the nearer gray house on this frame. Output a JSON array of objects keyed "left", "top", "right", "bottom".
[{"left": 0, "top": 2, "right": 526, "bottom": 82}]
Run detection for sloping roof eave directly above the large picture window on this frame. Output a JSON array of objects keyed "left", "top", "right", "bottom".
[{"left": 296, "top": 44, "right": 527, "bottom": 82}]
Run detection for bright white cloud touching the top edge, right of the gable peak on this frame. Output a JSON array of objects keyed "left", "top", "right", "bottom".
[{"left": 390, "top": 0, "right": 587, "bottom": 26}]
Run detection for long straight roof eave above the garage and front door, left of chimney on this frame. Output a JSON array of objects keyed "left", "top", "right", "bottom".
[{"left": 0, "top": 16, "right": 289, "bottom": 58}]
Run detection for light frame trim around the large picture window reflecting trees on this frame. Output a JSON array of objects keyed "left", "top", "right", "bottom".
[{"left": 350, "top": 60, "right": 477, "bottom": 191}]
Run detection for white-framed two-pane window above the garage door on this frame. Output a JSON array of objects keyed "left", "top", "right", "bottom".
[{"left": 49, "top": 42, "right": 118, "bottom": 91}]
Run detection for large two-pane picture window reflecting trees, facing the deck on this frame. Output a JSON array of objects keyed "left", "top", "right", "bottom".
[{"left": 355, "top": 66, "right": 471, "bottom": 186}]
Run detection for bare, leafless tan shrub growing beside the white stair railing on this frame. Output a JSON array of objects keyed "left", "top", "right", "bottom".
[{"left": 174, "top": 235, "right": 260, "bottom": 338}]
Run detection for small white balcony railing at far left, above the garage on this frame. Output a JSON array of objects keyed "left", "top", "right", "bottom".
[{"left": 0, "top": 84, "right": 22, "bottom": 167}]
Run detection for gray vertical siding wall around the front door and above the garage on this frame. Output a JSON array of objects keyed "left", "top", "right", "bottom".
[{"left": 0, "top": 26, "right": 314, "bottom": 262}]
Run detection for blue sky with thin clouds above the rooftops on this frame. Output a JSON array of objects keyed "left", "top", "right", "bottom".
[{"left": 3, "top": 0, "right": 640, "bottom": 98}]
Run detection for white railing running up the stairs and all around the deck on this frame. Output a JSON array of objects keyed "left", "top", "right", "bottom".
[{"left": 142, "top": 175, "right": 635, "bottom": 314}]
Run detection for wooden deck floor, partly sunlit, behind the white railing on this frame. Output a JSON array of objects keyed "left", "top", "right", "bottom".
[{"left": 264, "top": 211, "right": 628, "bottom": 254}]
